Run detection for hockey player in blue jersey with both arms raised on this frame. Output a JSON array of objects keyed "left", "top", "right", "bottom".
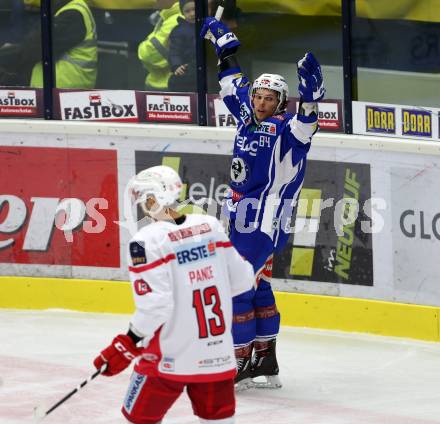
[{"left": 201, "top": 17, "right": 325, "bottom": 389}]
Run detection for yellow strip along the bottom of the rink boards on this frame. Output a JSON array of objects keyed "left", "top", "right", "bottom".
[{"left": 0, "top": 277, "right": 440, "bottom": 341}]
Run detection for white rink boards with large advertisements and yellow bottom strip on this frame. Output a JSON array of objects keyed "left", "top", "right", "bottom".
[{"left": 0, "top": 121, "right": 440, "bottom": 340}]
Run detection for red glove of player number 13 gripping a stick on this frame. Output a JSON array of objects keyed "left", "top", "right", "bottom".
[{"left": 93, "top": 334, "right": 142, "bottom": 377}]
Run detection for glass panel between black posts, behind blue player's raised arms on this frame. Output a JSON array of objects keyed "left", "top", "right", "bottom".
[{"left": 208, "top": 0, "right": 343, "bottom": 99}]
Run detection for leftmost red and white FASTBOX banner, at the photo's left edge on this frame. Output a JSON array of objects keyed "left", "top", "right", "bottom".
[{"left": 0, "top": 87, "right": 43, "bottom": 118}]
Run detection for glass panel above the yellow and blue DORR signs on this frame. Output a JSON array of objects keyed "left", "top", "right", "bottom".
[{"left": 353, "top": 0, "right": 440, "bottom": 107}]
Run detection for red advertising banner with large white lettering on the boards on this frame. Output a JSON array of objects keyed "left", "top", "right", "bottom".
[{"left": 0, "top": 146, "right": 120, "bottom": 267}]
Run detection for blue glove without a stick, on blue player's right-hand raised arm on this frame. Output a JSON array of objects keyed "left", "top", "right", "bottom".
[{"left": 298, "top": 53, "right": 325, "bottom": 103}]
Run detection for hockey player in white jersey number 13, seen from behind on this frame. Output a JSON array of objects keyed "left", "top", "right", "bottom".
[{"left": 94, "top": 166, "right": 254, "bottom": 424}]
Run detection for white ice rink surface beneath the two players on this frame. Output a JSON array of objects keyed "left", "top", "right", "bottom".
[{"left": 0, "top": 310, "right": 440, "bottom": 424}]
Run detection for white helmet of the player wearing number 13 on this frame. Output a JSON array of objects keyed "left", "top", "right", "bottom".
[{"left": 130, "top": 165, "right": 182, "bottom": 213}]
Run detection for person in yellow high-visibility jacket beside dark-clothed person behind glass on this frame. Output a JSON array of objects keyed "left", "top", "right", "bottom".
[{"left": 138, "top": 0, "right": 182, "bottom": 91}]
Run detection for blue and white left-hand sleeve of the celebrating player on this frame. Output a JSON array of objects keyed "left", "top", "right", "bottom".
[{"left": 219, "top": 73, "right": 253, "bottom": 125}]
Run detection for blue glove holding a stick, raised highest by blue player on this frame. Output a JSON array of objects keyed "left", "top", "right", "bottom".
[{"left": 200, "top": 16, "right": 240, "bottom": 58}]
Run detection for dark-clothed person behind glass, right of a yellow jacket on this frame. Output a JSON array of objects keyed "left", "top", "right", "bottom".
[{"left": 168, "top": 0, "right": 197, "bottom": 92}]
